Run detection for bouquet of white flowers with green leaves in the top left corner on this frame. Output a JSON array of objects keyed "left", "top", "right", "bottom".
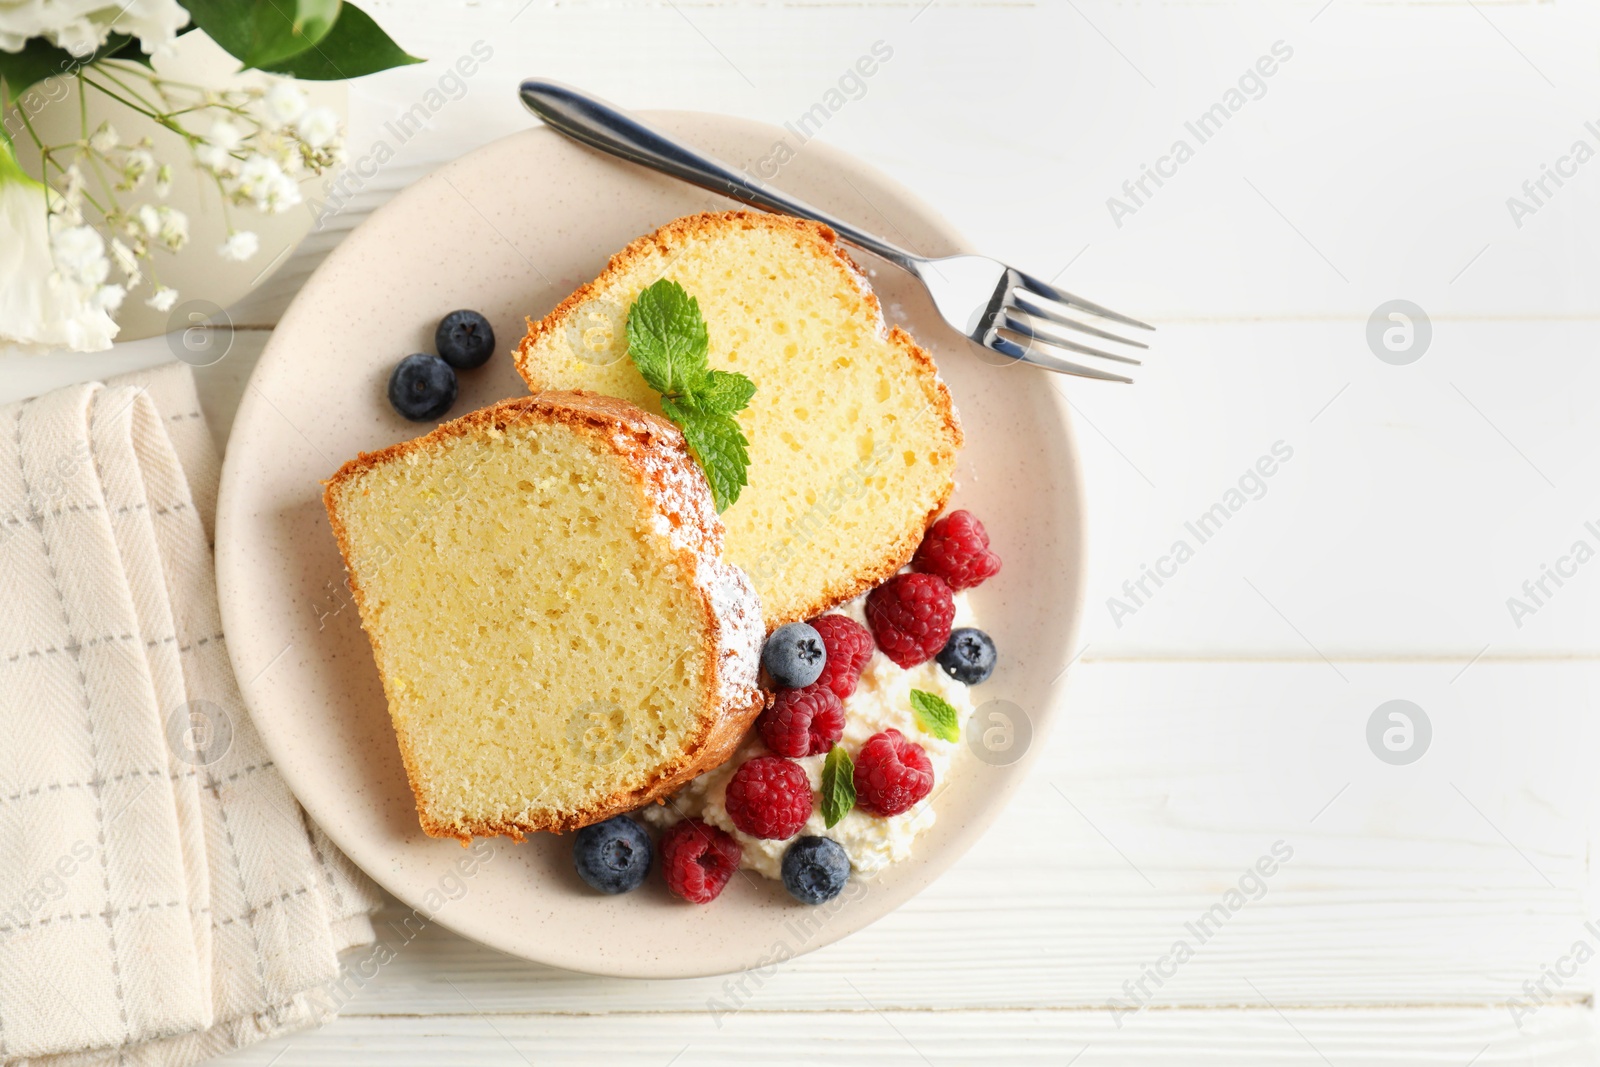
[{"left": 0, "top": 0, "right": 421, "bottom": 352}]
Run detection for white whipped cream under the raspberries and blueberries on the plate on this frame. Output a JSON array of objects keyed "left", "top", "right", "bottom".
[{"left": 640, "top": 593, "right": 974, "bottom": 878}]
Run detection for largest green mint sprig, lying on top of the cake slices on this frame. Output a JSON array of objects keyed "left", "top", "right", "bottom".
[{"left": 627, "top": 278, "right": 755, "bottom": 512}]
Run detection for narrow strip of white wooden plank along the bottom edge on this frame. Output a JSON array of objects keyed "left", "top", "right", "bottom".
[{"left": 216, "top": 1001, "right": 1597, "bottom": 1067}]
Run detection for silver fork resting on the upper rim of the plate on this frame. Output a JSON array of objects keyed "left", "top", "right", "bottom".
[{"left": 522, "top": 78, "right": 1154, "bottom": 382}]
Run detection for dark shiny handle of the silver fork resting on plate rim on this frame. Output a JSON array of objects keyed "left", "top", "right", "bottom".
[{"left": 520, "top": 78, "right": 922, "bottom": 272}]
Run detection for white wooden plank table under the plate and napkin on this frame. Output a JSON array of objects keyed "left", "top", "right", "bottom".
[{"left": 0, "top": 0, "right": 1600, "bottom": 1067}]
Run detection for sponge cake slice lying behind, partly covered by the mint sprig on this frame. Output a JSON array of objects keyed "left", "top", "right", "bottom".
[{"left": 517, "top": 211, "right": 962, "bottom": 629}]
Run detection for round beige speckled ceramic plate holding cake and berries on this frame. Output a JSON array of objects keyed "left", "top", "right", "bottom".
[{"left": 218, "top": 112, "right": 1083, "bottom": 977}]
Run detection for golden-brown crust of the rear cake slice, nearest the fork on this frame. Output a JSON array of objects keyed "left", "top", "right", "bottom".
[{"left": 514, "top": 211, "right": 965, "bottom": 633}]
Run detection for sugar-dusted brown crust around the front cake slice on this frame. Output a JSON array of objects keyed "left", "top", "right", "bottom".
[{"left": 323, "top": 390, "right": 770, "bottom": 845}]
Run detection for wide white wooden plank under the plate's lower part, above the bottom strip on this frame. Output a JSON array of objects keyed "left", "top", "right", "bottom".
[{"left": 275, "top": 662, "right": 1600, "bottom": 1014}]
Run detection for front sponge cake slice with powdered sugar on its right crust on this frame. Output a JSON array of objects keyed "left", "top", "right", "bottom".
[{"left": 323, "top": 392, "right": 762, "bottom": 841}]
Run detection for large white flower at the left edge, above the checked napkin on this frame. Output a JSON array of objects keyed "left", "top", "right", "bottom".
[{"left": 0, "top": 141, "right": 117, "bottom": 352}]
